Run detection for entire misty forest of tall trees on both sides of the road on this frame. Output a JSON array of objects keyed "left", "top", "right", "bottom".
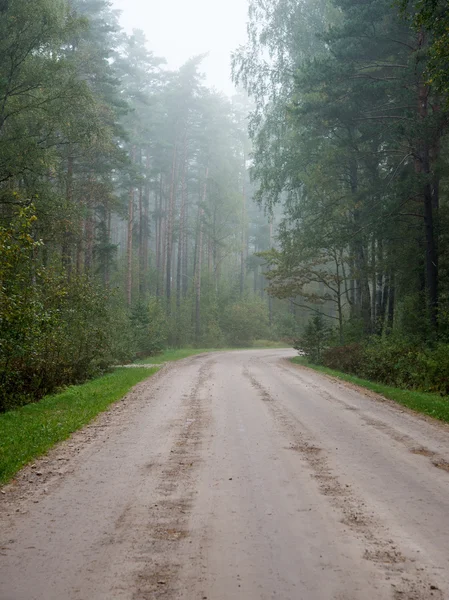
[{"left": 0, "top": 0, "right": 449, "bottom": 411}]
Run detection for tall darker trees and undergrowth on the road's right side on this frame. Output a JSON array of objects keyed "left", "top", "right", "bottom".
[{"left": 233, "top": 0, "right": 449, "bottom": 414}]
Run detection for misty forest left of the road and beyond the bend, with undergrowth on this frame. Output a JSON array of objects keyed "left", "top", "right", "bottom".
[{"left": 0, "top": 0, "right": 293, "bottom": 410}]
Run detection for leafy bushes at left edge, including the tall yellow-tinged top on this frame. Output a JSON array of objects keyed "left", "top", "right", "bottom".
[{"left": 0, "top": 207, "right": 142, "bottom": 411}]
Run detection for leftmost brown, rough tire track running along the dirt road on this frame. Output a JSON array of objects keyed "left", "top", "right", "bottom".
[{"left": 126, "top": 360, "right": 215, "bottom": 600}]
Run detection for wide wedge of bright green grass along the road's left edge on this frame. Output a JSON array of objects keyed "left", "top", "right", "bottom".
[{"left": 0, "top": 368, "right": 158, "bottom": 484}]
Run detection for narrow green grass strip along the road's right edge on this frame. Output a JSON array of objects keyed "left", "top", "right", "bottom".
[{"left": 291, "top": 356, "right": 449, "bottom": 423}]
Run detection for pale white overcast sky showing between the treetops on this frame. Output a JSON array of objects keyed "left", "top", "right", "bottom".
[{"left": 112, "top": 0, "right": 247, "bottom": 94}]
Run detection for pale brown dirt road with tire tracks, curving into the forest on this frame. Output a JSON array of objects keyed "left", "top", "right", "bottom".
[{"left": 0, "top": 350, "right": 449, "bottom": 600}]
